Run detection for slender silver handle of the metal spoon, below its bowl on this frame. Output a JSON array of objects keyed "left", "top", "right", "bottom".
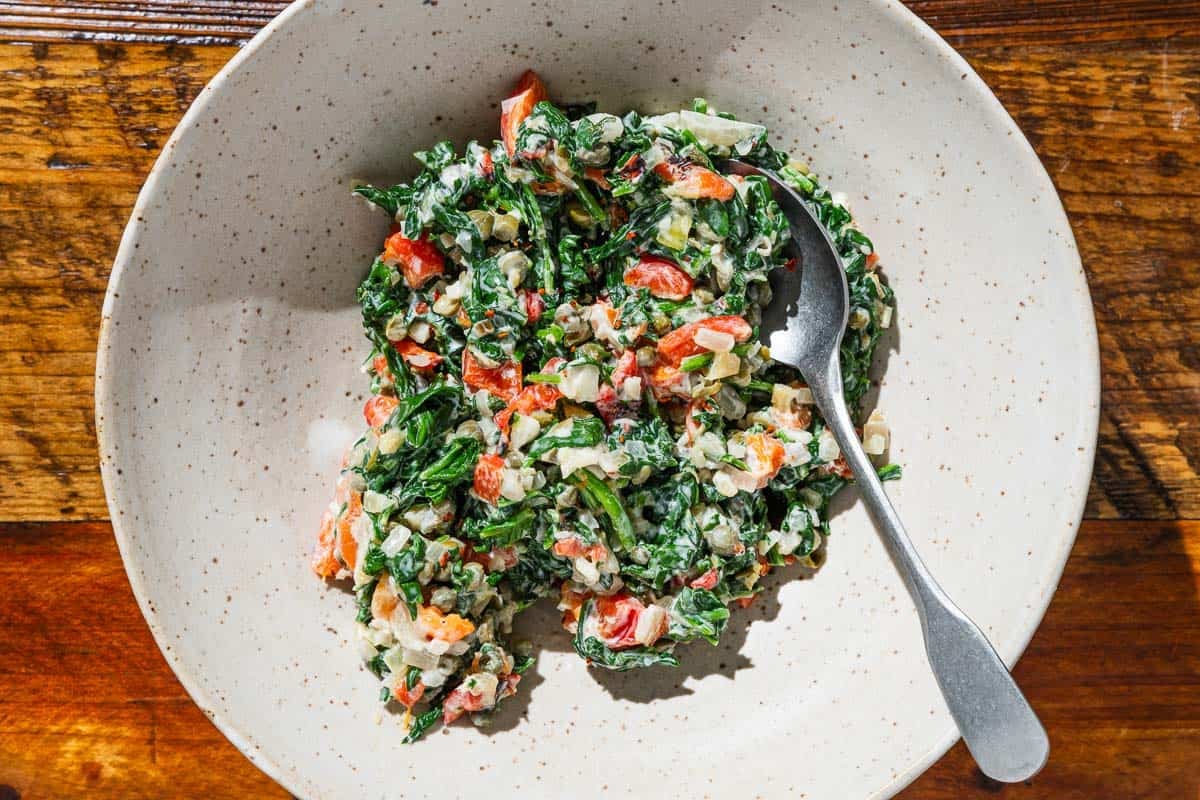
[{"left": 805, "top": 351, "right": 1050, "bottom": 783}]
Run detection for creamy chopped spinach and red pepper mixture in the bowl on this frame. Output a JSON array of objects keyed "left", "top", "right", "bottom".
[{"left": 312, "top": 72, "right": 899, "bottom": 740}]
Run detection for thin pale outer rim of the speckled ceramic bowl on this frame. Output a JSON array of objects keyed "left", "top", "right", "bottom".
[{"left": 95, "top": 0, "right": 1100, "bottom": 800}]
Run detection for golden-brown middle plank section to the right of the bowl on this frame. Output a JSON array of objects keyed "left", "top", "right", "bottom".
[{"left": 967, "top": 47, "right": 1200, "bottom": 519}]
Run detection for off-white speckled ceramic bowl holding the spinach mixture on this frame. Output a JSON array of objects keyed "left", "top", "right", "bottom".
[{"left": 96, "top": 0, "right": 1098, "bottom": 800}]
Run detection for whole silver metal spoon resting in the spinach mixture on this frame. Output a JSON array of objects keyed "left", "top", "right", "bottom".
[{"left": 720, "top": 160, "right": 1050, "bottom": 783}]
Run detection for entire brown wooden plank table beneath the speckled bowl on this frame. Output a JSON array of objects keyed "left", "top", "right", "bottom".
[{"left": 0, "top": 0, "right": 1200, "bottom": 800}]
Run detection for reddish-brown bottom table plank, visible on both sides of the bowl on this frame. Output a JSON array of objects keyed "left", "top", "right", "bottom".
[{"left": 0, "top": 522, "right": 1200, "bottom": 800}]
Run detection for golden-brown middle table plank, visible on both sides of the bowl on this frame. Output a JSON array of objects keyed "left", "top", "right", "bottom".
[{"left": 0, "top": 25, "right": 1200, "bottom": 519}]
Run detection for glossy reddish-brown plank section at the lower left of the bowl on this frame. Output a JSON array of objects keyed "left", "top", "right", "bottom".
[{"left": 0, "top": 523, "right": 288, "bottom": 800}]
